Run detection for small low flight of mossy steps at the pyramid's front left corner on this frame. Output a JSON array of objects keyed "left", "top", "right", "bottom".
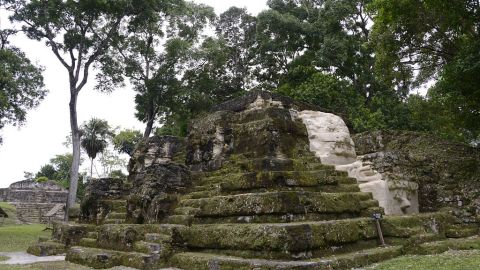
[{"left": 66, "top": 224, "right": 177, "bottom": 269}]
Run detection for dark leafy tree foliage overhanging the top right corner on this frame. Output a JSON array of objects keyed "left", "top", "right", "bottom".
[{"left": 370, "top": 0, "right": 480, "bottom": 142}]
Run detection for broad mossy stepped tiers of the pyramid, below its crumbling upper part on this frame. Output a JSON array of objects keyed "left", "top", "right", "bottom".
[{"left": 62, "top": 153, "right": 480, "bottom": 270}]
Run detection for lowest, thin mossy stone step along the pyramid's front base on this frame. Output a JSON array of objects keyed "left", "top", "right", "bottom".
[{"left": 170, "top": 246, "right": 401, "bottom": 270}]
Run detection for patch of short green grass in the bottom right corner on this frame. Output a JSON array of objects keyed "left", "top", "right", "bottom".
[{"left": 365, "top": 250, "right": 480, "bottom": 270}]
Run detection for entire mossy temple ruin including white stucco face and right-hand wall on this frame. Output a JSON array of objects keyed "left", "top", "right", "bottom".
[{"left": 29, "top": 91, "right": 480, "bottom": 270}]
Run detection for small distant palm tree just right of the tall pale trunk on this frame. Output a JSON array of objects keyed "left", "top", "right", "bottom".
[{"left": 81, "top": 118, "right": 112, "bottom": 177}]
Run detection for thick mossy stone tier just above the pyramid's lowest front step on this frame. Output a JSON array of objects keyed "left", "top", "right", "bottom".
[{"left": 176, "top": 218, "right": 377, "bottom": 258}]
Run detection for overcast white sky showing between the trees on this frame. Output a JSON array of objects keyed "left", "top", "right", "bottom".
[{"left": 0, "top": 0, "right": 266, "bottom": 188}]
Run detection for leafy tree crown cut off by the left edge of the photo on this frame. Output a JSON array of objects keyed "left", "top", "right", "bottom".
[{"left": 0, "top": 29, "right": 47, "bottom": 144}]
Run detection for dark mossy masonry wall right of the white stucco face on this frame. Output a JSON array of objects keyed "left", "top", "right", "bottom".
[{"left": 353, "top": 131, "right": 480, "bottom": 222}]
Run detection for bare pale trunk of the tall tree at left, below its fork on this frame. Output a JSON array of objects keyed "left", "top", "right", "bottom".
[{"left": 65, "top": 89, "right": 81, "bottom": 221}]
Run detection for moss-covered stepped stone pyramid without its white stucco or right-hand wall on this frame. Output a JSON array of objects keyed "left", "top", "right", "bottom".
[{"left": 30, "top": 92, "right": 480, "bottom": 270}]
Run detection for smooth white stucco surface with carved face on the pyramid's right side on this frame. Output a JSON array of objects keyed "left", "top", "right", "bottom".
[{"left": 298, "top": 111, "right": 418, "bottom": 215}]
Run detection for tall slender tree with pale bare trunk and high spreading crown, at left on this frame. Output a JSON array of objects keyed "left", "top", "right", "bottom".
[{"left": 7, "top": 0, "right": 142, "bottom": 217}]
